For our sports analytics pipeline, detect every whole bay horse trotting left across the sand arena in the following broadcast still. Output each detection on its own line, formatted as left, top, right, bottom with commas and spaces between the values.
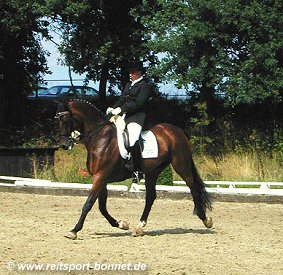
55, 100, 213, 239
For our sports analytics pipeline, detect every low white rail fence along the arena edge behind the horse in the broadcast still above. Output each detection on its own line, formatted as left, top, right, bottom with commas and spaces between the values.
0, 176, 283, 196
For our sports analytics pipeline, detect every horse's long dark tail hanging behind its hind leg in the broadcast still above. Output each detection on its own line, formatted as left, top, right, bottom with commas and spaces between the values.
191, 159, 212, 220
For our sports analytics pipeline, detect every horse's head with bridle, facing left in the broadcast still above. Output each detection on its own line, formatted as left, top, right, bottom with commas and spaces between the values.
55, 104, 82, 150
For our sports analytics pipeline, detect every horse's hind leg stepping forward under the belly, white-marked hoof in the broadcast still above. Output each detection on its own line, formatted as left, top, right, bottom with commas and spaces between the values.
132, 168, 163, 237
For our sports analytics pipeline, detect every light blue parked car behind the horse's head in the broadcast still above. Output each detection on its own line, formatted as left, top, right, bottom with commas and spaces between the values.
28, 85, 98, 100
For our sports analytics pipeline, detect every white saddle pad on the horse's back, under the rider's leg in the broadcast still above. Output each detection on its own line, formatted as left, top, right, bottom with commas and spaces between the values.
110, 116, 158, 159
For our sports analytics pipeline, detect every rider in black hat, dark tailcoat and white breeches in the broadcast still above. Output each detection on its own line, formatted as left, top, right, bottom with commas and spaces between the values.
106, 61, 152, 183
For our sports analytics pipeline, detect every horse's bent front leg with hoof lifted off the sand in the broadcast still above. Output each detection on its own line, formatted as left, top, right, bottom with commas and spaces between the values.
98, 185, 129, 230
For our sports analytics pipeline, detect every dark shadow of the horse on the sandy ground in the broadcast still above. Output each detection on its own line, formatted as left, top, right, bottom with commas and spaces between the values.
91, 228, 216, 238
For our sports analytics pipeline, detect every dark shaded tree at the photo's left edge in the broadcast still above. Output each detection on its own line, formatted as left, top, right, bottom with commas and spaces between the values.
0, 0, 47, 124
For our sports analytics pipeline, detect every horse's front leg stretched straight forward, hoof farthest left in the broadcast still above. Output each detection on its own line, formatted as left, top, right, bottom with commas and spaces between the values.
65, 181, 103, 240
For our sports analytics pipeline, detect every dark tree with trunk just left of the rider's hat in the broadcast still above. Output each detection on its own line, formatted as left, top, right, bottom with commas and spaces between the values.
44, 0, 154, 106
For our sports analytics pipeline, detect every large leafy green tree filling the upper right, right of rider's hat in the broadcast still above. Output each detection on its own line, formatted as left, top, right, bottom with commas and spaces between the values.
141, 0, 283, 114
